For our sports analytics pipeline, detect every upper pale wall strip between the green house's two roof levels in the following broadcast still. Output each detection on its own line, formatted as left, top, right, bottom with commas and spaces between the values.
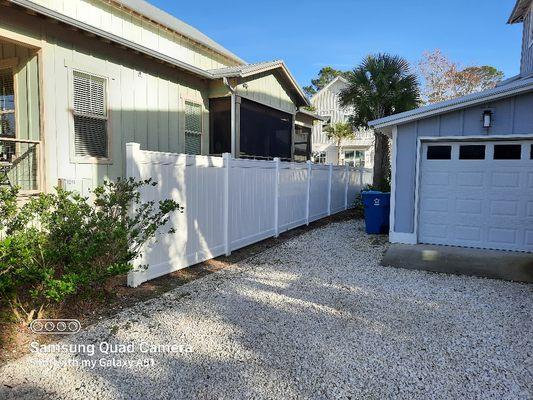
29, 0, 238, 69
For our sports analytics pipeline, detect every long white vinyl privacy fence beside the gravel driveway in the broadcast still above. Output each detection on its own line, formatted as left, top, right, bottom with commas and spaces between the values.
126, 143, 372, 287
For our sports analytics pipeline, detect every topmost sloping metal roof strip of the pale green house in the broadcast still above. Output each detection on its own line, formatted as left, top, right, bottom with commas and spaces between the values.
115, 0, 246, 64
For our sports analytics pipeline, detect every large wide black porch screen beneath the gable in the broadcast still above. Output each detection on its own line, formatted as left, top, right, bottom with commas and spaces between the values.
240, 99, 292, 158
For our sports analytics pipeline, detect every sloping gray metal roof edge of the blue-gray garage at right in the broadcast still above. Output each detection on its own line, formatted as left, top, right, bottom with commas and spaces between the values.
368, 76, 533, 129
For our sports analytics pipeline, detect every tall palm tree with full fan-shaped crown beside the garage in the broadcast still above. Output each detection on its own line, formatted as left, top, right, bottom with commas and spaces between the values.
340, 54, 420, 190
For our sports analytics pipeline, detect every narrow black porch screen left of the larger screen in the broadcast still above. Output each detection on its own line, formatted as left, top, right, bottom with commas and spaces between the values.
209, 97, 231, 154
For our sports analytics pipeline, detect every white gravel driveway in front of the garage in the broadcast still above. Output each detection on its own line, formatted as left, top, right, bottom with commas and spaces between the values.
0, 221, 533, 399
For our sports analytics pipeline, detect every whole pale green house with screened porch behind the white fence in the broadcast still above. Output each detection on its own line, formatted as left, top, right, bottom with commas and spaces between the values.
0, 0, 312, 193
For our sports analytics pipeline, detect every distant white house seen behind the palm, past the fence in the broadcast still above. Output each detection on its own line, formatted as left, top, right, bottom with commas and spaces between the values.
311, 76, 374, 168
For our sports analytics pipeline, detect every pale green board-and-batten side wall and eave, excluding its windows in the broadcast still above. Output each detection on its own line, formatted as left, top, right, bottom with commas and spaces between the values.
0, 7, 209, 190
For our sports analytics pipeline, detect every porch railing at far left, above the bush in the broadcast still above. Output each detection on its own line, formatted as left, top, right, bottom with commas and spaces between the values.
0, 137, 41, 193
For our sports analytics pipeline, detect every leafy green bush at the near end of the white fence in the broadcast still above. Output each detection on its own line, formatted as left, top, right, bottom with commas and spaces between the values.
0, 179, 183, 319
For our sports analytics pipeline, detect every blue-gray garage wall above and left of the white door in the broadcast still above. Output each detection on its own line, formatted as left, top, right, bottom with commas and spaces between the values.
393, 92, 533, 234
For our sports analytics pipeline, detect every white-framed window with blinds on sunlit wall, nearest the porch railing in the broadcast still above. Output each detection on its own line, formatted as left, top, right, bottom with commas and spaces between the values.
73, 71, 108, 158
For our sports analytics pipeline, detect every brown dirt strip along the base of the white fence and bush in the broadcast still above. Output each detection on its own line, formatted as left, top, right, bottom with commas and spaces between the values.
0, 210, 356, 365
